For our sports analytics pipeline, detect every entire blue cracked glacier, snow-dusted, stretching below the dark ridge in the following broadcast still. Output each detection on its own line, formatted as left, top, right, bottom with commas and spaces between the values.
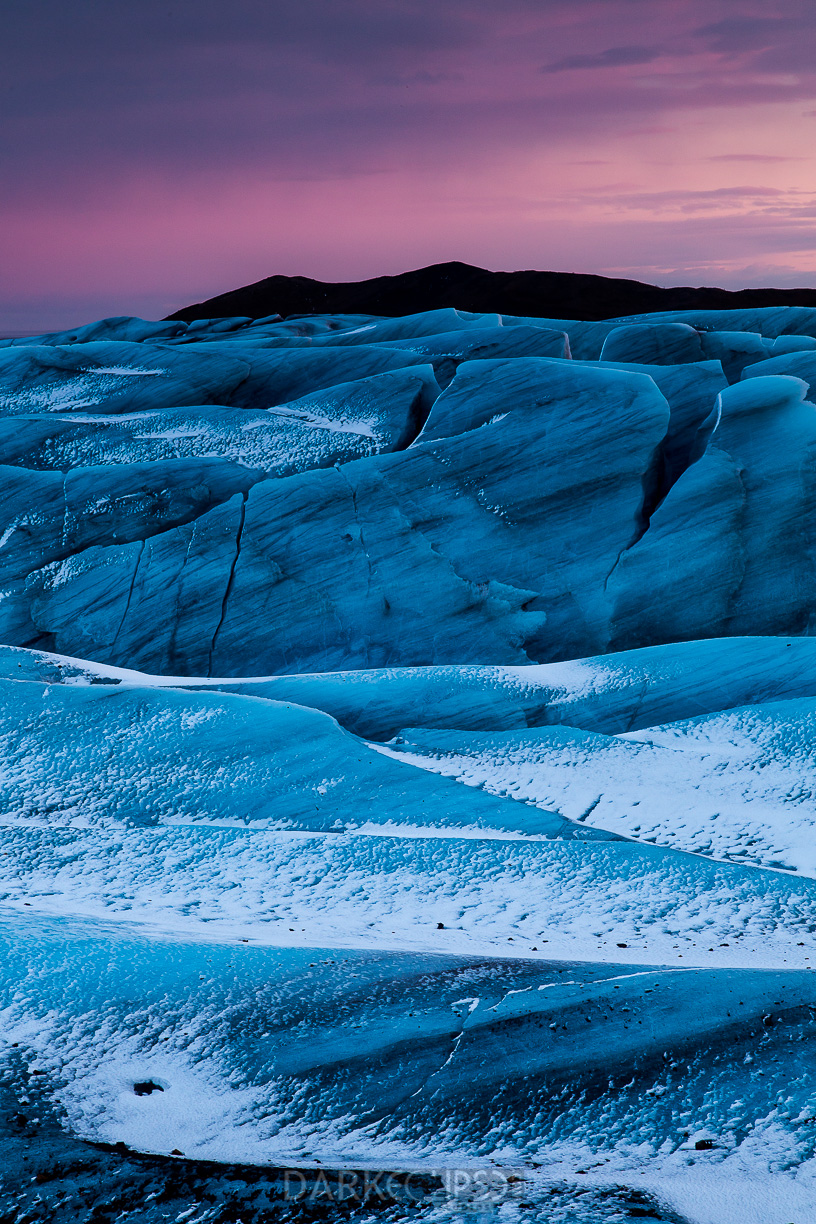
0, 307, 816, 1224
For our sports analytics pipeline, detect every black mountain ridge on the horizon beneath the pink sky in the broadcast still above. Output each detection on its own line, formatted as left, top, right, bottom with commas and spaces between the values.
168, 261, 816, 322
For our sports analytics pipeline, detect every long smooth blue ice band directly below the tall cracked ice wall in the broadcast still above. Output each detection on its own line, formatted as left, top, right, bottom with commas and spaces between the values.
0, 638, 816, 741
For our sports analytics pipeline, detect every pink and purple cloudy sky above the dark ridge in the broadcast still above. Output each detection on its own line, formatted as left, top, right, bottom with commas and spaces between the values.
0, 0, 816, 330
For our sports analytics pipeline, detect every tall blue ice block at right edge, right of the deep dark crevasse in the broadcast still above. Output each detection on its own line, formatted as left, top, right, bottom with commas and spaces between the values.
609, 372, 816, 647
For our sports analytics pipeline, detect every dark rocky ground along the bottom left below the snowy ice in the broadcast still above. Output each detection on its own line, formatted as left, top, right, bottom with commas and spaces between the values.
0, 1082, 684, 1224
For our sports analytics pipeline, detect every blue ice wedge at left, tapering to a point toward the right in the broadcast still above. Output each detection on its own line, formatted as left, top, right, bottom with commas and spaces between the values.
0, 681, 611, 837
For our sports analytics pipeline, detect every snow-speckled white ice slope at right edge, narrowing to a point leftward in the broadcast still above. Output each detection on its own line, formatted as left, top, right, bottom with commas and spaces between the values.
381, 699, 816, 875
